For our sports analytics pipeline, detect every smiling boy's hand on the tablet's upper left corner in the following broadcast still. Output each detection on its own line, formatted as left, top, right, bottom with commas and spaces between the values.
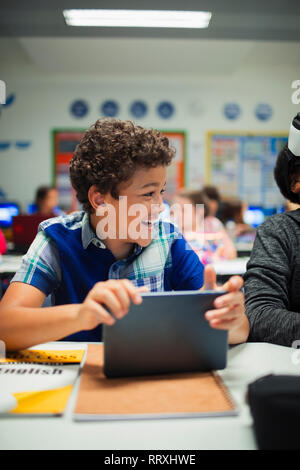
77, 279, 149, 330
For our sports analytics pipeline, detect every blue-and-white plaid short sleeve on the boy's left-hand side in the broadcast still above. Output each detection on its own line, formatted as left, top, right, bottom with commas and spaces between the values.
11, 231, 61, 296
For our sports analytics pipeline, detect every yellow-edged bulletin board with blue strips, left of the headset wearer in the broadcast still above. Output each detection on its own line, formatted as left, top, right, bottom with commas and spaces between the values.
206, 131, 288, 208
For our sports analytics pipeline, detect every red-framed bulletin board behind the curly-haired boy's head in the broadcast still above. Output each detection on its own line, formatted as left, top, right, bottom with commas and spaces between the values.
52, 129, 186, 211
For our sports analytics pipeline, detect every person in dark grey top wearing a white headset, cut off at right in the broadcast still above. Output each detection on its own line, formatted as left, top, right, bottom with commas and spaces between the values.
244, 113, 300, 346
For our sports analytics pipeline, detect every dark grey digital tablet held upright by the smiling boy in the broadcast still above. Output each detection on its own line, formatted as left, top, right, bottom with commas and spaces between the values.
103, 291, 228, 377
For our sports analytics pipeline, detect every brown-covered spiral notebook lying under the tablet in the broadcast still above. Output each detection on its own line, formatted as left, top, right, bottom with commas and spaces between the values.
74, 344, 238, 421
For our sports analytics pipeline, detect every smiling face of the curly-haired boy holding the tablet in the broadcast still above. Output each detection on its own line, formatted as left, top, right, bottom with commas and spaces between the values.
91, 165, 166, 257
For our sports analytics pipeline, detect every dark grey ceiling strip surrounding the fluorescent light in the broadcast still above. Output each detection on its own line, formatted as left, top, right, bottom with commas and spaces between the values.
0, 0, 300, 41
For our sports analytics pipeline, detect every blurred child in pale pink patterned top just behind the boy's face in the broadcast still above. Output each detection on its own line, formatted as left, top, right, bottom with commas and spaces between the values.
173, 190, 237, 265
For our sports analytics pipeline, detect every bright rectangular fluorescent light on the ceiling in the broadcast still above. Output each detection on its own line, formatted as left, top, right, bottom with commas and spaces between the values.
63, 10, 211, 28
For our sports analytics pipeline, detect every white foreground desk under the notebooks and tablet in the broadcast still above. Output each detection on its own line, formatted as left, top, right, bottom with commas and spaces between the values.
0, 343, 300, 450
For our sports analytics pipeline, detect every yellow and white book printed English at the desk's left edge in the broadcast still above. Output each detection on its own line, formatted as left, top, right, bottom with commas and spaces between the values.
0, 347, 85, 416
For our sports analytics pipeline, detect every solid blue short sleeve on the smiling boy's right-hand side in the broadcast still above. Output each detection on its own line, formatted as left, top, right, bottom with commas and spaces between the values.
165, 237, 204, 290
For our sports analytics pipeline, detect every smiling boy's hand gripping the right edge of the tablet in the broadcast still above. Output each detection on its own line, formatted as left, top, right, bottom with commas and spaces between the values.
201, 266, 245, 331
